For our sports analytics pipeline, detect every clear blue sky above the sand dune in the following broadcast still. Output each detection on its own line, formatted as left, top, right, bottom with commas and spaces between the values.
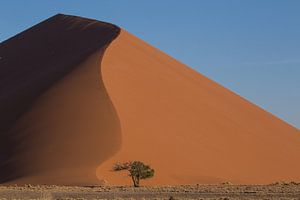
0, 0, 300, 128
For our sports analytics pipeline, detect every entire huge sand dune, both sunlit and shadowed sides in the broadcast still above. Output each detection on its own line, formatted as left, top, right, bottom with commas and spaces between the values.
0, 15, 300, 185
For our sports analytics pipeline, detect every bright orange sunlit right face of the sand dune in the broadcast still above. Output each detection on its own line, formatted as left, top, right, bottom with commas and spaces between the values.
98, 30, 300, 184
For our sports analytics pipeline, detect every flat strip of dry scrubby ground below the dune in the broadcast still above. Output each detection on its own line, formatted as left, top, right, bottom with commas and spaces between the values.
0, 183, 300, 200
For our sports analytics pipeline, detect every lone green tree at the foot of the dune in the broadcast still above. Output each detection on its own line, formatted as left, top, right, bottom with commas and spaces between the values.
113, 161, 154, 187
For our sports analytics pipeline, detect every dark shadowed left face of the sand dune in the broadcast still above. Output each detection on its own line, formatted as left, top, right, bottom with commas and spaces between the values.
0, 15, 121, 184
